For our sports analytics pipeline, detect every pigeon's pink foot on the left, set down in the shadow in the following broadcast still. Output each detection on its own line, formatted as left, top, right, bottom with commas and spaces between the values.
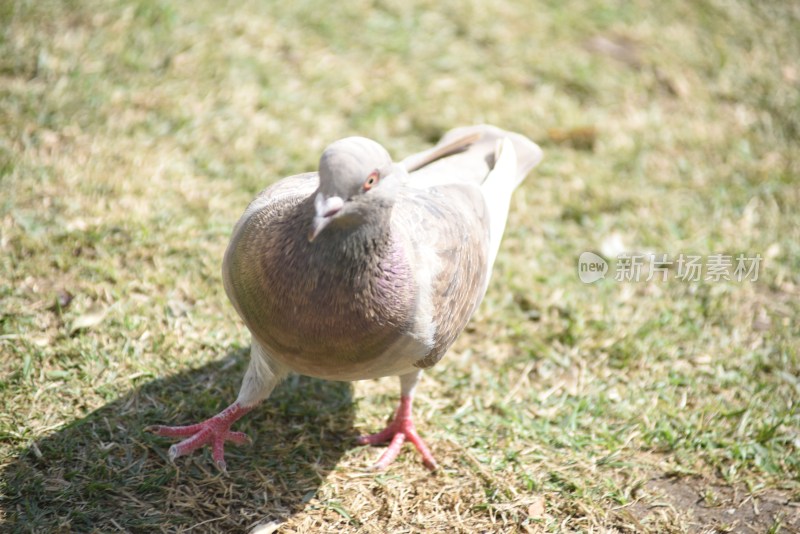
145, 402, 253, 472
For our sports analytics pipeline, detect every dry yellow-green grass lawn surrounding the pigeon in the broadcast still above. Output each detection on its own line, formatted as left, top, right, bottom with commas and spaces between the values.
0, 0, 800, 532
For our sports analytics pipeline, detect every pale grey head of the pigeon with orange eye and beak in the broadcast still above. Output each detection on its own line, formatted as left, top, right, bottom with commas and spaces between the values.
308, 137, 405, 241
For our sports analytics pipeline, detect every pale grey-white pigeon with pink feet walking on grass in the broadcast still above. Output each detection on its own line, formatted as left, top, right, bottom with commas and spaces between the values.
148, 125, 542, 472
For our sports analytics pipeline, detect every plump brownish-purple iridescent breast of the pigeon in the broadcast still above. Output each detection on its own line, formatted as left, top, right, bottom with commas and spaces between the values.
226, 180, 423, 380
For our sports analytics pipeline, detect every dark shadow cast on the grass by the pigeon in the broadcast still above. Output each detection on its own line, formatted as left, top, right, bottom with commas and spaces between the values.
0, 349, 356, 532
